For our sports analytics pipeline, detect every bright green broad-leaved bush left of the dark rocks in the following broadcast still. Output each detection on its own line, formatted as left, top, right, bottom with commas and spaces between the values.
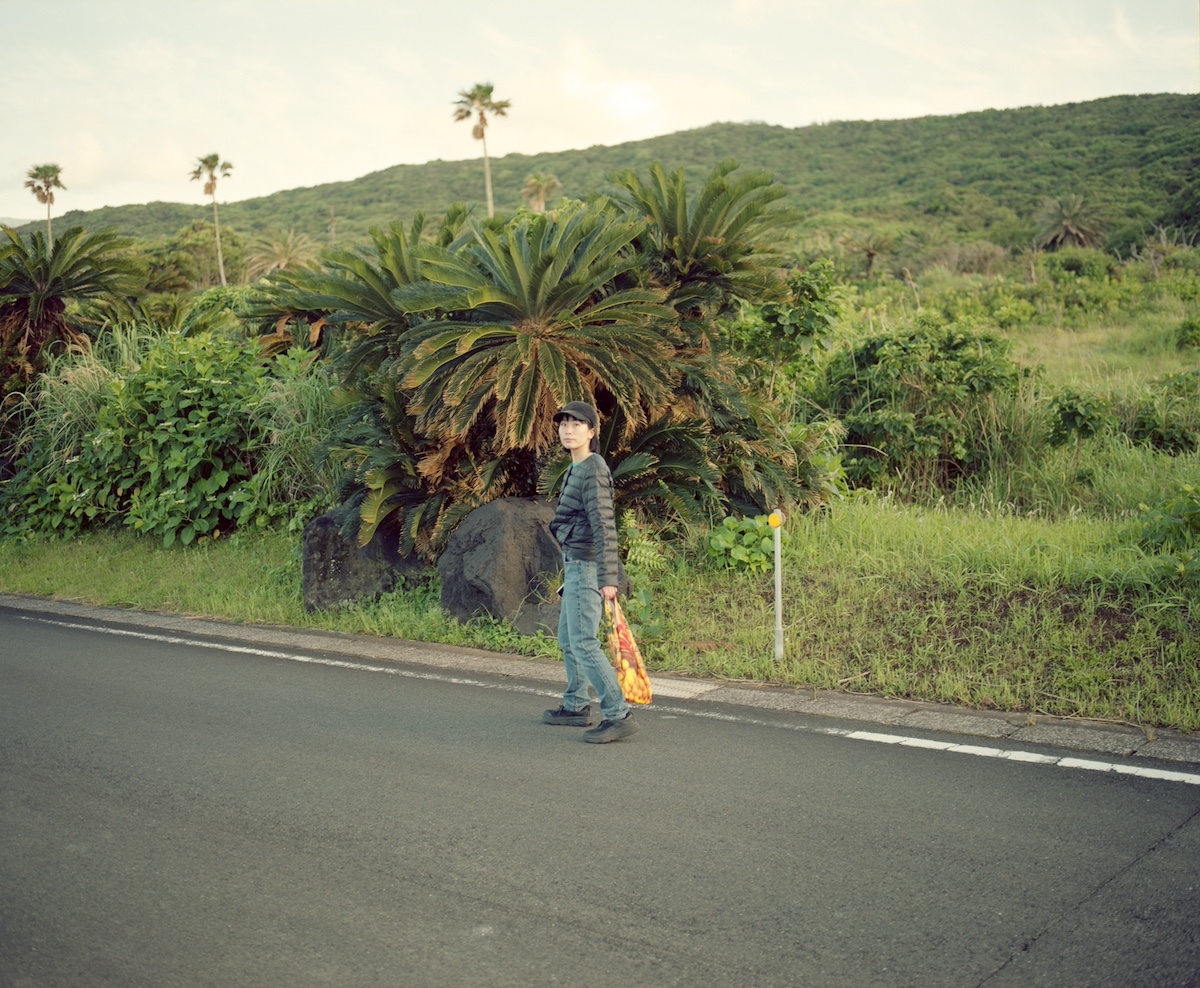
6, 335, 281, 545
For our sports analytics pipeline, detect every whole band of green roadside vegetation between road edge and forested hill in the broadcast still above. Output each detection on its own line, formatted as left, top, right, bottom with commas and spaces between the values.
0, 94, 1200, 731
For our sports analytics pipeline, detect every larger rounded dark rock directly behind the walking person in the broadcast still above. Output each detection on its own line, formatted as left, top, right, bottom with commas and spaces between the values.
438, 497, 563, 635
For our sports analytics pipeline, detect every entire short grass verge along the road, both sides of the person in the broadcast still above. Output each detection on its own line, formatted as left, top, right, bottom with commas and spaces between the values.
0, 501, 1200, 731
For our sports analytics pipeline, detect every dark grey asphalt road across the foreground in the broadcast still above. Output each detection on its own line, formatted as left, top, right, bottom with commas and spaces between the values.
0, 607, 1200, 988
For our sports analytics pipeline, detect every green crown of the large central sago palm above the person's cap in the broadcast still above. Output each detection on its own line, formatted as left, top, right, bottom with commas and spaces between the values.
392, 205, 674, 455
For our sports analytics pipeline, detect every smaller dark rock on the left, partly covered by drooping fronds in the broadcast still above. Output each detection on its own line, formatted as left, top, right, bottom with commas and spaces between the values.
304, 508, 430, 611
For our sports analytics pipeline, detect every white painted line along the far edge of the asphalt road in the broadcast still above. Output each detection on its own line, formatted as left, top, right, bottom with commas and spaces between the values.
19, 615, 1200, 785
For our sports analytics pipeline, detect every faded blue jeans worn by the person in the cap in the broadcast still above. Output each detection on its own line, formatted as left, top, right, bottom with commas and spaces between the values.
558, 559, 629, 720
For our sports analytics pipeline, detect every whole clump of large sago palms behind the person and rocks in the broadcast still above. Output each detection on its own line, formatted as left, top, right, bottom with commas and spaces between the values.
272, 162, 830, 552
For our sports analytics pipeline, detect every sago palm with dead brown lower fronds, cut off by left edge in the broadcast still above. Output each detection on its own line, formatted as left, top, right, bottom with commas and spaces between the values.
0, 227, 144, 444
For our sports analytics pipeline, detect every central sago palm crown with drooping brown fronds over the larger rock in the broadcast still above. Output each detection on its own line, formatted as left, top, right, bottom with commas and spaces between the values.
355, 205, 674, 553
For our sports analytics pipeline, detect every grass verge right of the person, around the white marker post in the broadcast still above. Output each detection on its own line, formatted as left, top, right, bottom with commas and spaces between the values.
647, 499, 1200, 730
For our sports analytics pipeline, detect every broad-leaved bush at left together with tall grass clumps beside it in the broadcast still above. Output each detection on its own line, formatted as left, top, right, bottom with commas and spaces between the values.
0, 333, 330, 545
